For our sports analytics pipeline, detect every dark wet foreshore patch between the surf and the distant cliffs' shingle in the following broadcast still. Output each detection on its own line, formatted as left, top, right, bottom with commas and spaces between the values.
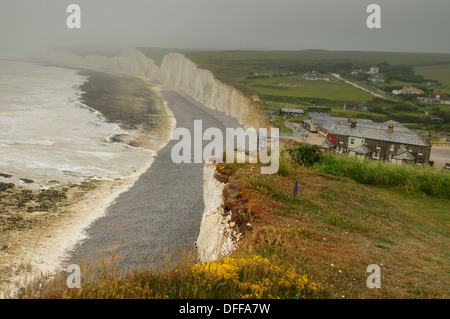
80, 70, 172, 151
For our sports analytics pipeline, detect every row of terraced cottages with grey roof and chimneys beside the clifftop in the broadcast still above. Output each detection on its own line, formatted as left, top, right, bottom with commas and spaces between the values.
308, 114, 431, 165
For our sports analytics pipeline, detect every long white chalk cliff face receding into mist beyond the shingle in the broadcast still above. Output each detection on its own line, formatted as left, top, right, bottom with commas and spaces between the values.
47, 49, 272, 129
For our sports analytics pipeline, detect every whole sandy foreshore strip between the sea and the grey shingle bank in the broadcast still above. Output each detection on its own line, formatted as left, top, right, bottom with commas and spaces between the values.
0, 70, 175, 298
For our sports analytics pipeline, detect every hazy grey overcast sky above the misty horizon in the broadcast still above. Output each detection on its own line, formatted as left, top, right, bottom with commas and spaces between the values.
0, 0, 450, 54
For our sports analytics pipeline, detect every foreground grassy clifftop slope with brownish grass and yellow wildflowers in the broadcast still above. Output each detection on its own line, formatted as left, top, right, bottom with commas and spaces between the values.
18, 154, 450, 299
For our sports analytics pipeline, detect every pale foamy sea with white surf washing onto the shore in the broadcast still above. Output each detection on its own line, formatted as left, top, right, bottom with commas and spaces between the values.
0, 60, 155, 187
